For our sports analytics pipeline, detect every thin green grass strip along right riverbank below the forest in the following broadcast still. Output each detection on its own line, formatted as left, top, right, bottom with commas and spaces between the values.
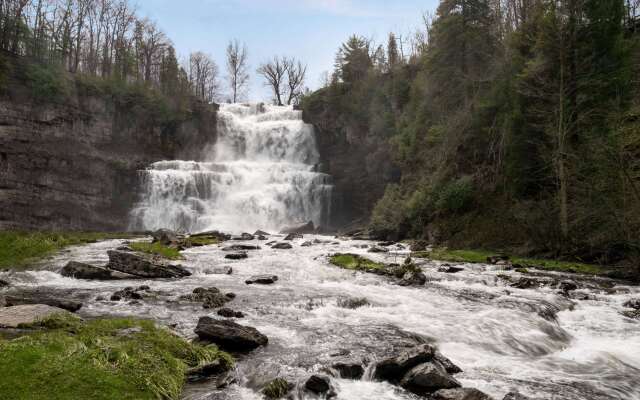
411, 248, 609, 275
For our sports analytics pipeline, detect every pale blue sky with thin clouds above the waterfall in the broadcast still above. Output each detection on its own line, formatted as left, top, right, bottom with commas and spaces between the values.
137, 0, 438, 101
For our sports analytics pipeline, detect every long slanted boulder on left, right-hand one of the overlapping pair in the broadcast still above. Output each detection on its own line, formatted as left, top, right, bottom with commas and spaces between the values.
107, 250, 191, 278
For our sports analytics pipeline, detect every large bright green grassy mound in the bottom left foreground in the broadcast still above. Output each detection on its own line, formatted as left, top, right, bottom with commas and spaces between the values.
0, 318, 233, 400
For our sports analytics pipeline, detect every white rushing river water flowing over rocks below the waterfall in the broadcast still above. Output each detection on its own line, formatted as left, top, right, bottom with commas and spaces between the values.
5, 236, 640, 400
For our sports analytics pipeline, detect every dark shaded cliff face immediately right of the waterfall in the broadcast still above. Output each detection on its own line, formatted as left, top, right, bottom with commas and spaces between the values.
303, 95, 398, 228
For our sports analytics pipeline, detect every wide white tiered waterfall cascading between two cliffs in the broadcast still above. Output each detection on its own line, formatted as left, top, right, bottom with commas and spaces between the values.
130, 104, 332, 233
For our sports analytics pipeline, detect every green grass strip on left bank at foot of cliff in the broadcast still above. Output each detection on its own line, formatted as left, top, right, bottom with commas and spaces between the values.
0, 231, 141, 270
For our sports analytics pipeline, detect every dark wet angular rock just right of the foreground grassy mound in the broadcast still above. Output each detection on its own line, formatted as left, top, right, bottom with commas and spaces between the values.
195, 317, 269, 351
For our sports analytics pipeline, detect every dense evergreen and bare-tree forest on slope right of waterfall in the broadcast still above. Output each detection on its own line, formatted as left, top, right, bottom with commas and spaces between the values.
303, 0, 640, 268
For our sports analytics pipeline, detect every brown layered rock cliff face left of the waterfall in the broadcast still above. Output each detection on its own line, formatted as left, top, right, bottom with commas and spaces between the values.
0, 91, 216, 230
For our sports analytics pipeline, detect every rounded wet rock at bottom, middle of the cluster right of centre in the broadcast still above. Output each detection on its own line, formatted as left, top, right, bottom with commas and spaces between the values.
400, 362, 461, 395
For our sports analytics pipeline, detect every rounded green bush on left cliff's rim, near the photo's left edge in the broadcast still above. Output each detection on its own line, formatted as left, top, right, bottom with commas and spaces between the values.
24, 63, 71, 102
